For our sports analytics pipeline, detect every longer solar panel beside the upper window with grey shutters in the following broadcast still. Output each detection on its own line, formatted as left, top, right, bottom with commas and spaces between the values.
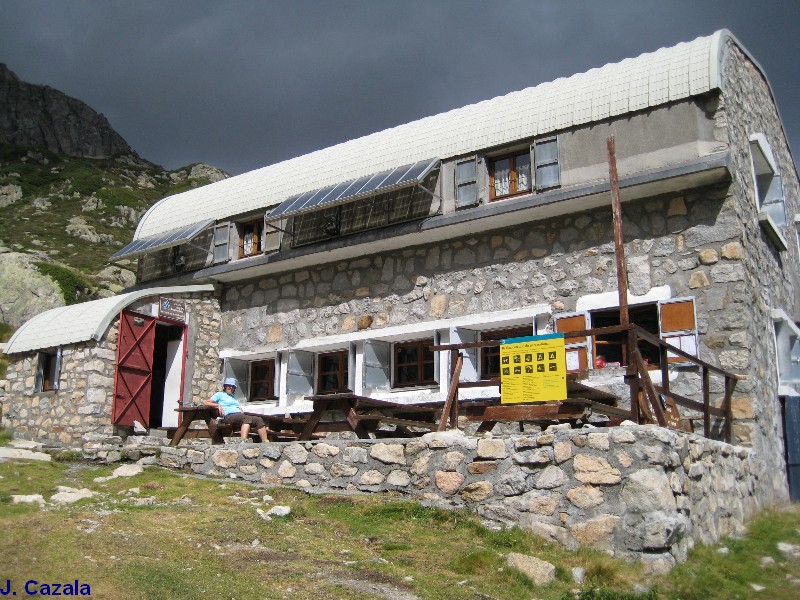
268, 158, 439, 220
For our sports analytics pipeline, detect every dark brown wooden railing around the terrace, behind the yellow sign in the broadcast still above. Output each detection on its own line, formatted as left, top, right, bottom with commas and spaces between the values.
432, 325, 744, 443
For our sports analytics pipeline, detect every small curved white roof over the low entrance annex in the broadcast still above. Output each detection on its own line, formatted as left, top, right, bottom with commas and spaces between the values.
5, 284, 214, 354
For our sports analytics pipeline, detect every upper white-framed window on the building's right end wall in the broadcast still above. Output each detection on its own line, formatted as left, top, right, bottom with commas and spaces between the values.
750, 133, 789, 252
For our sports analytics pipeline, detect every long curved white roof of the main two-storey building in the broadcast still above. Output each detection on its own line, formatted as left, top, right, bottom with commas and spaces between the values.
134, 30, 741, 240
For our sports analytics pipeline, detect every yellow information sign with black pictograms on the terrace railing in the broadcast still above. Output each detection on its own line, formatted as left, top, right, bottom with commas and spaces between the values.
500, 333, 567, 404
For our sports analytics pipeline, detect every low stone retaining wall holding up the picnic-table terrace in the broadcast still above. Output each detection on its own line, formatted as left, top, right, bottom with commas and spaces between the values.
100, 422, 768, 571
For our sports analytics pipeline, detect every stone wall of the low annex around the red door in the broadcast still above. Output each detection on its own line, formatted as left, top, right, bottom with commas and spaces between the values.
0, 294, 219, 445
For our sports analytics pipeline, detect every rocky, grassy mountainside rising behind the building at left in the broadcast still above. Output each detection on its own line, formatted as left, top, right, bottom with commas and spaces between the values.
0, 65, 228, 327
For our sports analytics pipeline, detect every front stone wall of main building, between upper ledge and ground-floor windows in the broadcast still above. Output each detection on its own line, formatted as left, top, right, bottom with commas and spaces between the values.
220, 184, 757, 426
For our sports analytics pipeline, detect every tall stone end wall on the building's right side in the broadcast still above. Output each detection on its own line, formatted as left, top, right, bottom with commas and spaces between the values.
721, 44, 800, 497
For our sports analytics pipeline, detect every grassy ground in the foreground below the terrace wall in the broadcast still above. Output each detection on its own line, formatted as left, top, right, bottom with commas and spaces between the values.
0, 462, 800, 600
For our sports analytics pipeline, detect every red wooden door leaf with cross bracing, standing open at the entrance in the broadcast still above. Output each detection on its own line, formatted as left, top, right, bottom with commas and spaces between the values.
111, 310, 156, 427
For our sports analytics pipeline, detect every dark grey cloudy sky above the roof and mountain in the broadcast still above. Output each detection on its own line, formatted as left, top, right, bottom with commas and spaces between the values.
0, 0, 800, 174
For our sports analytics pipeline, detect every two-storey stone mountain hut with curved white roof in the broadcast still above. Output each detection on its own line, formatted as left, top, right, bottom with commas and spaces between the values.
4, 31, 800, 501
